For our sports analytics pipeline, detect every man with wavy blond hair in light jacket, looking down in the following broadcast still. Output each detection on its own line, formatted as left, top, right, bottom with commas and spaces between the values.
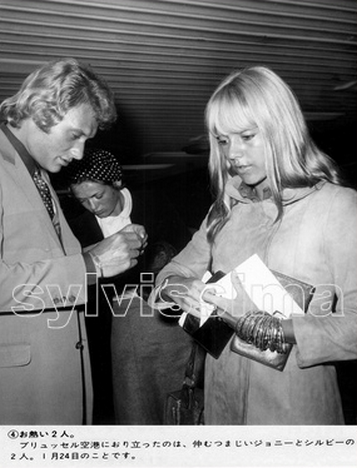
0, 59, 146, 425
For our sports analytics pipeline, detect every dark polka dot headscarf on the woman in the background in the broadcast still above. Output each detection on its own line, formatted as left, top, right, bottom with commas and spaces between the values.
66, 149, 122, 185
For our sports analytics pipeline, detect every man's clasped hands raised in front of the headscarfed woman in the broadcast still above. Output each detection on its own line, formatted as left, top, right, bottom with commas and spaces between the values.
87, 224, 147, 278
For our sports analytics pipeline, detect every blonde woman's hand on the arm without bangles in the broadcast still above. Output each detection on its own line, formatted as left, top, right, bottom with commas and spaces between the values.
159, 276, 205, 317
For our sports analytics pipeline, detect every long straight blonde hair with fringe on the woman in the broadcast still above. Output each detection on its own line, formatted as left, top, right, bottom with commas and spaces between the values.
205, 66, 342, 242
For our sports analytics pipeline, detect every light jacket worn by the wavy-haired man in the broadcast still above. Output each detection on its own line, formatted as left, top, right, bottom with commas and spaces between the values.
0, 131, 92, 425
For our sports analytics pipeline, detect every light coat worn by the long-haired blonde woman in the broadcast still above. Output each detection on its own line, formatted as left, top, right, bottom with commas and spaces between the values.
157, 178, 357, 425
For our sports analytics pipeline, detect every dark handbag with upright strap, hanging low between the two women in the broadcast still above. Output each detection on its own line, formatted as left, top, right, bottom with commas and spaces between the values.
164, 342, 206, 426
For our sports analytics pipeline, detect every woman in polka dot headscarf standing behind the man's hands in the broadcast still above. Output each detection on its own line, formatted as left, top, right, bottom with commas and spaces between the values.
65, 149, 190, 425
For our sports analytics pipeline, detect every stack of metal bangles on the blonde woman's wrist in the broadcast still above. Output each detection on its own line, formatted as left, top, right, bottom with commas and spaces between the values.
235, 310, 288, 354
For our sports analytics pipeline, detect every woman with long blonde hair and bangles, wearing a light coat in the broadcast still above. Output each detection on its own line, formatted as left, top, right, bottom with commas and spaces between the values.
152, 66, 357, 425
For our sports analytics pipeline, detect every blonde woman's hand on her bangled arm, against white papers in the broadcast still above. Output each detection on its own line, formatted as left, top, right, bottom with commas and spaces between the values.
202, 270, 257, 326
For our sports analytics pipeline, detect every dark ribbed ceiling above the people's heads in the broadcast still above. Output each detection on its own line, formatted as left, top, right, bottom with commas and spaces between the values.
0, 0, 356, 153
